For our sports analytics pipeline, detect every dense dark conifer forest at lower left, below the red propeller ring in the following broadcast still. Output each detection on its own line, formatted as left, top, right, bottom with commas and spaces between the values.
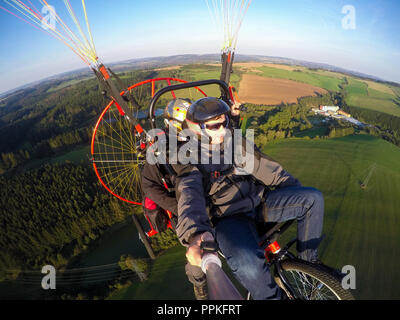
0, 163, 140, 279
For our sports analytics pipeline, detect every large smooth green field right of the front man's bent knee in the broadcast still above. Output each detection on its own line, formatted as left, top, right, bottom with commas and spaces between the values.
263, 135, 400, 299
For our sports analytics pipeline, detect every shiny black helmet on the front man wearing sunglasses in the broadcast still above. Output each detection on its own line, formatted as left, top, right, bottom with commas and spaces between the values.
186, 97, 230, 123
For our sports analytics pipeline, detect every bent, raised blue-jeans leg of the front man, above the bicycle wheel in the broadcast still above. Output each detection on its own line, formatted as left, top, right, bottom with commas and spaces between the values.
264, 187, 324, 261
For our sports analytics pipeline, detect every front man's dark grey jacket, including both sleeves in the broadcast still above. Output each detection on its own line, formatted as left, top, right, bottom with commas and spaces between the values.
173, 131, 301, 246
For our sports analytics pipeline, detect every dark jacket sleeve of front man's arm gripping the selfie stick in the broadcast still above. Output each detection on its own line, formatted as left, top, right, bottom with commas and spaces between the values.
174, 165, 213, 246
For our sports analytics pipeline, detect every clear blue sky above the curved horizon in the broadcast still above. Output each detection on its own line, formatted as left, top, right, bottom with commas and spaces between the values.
0, 0, 400, 92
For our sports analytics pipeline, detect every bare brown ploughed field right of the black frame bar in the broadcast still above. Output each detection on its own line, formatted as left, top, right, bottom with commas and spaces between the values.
239, 74, 327, 105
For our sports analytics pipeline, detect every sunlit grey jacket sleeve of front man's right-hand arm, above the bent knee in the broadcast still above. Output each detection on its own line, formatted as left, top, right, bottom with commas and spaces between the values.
243, 139, 301, 188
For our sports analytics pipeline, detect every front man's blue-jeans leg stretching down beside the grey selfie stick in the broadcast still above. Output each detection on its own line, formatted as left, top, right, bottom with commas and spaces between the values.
215, 216, 280, 300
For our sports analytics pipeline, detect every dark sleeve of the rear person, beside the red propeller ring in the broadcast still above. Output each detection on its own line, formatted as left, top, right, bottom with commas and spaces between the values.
141, 163, 178, 215
